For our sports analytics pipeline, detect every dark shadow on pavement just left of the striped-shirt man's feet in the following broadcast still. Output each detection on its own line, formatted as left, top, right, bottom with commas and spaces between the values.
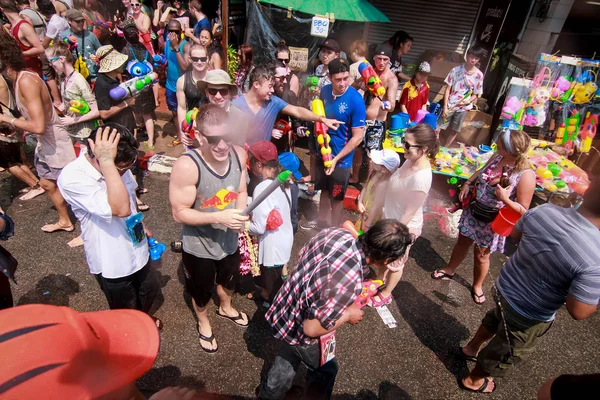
394, 281, 469, 377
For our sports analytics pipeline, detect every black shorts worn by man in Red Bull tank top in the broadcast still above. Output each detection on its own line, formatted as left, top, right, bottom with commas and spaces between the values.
183, 250, 240, 307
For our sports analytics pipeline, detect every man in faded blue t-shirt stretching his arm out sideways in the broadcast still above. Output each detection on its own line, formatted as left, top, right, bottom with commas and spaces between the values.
231, 66, 342, 145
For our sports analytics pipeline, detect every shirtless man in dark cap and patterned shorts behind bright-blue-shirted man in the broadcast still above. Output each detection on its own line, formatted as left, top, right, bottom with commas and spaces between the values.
350, 44, 398, 183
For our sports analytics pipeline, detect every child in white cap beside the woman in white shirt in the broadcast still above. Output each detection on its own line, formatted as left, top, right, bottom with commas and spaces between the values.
356, 149, 400, 231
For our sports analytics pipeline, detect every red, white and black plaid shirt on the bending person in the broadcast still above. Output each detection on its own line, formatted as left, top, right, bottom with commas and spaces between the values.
265, 229, 369, 345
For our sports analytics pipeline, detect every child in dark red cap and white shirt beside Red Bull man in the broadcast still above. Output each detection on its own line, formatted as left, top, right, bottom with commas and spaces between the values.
248, 140, 294, 302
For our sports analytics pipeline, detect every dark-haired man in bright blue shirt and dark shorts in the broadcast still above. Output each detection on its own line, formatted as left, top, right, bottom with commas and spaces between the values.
300, 58, 367, 229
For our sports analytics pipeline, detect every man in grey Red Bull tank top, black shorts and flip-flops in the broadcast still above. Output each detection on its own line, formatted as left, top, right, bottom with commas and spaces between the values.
169, 104, 248, 353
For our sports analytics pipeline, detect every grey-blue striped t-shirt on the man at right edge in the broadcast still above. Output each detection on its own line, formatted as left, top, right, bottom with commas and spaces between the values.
496, 204, 600, 322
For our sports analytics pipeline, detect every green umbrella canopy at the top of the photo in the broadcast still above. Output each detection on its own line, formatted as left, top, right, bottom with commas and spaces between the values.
259, 0, 390, 22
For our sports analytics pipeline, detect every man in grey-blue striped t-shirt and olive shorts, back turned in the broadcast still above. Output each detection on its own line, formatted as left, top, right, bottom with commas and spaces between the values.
459, 178, 600, 393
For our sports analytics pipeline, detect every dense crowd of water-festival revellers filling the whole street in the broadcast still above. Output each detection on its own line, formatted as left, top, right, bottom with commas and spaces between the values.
0, 0, 600, 400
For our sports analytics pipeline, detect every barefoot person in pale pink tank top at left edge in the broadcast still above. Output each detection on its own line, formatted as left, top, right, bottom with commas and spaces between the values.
0, 31, 75, 232
